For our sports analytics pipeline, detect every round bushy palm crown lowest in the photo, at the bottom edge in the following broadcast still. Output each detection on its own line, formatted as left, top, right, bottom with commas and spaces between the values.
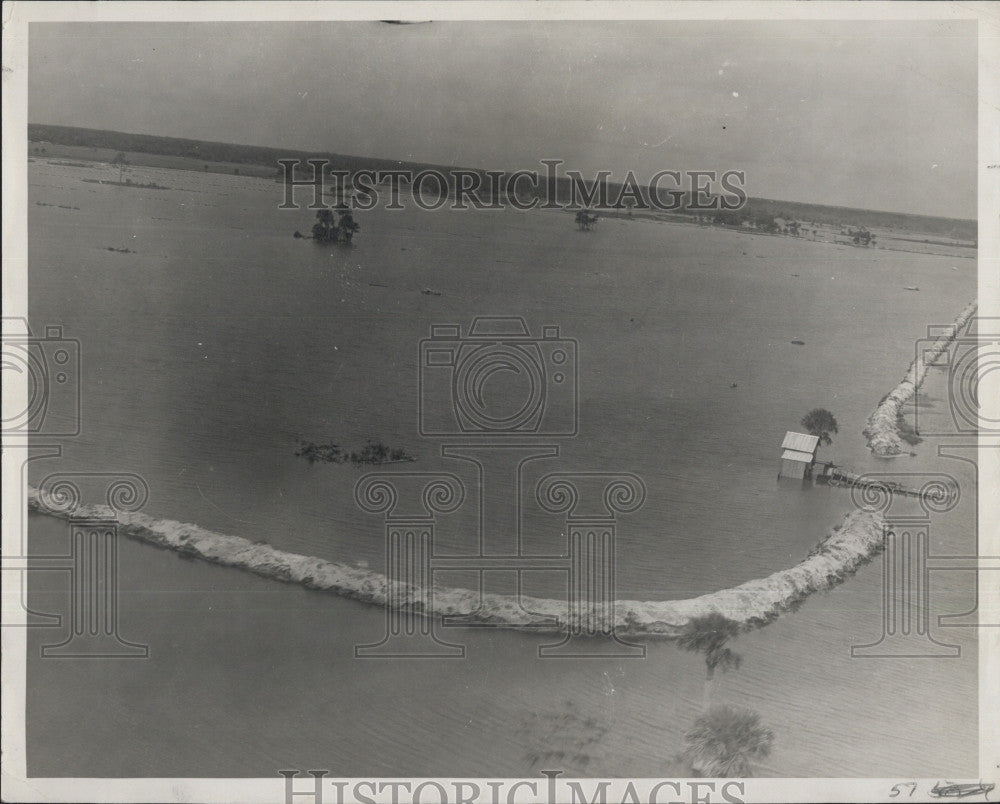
684, 704, 774, 778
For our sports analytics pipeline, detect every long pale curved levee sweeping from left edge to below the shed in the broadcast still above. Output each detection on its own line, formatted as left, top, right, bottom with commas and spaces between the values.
28, 489, 884, 638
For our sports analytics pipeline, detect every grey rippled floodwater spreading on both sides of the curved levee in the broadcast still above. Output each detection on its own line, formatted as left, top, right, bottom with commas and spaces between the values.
27, 162, 978, 777
